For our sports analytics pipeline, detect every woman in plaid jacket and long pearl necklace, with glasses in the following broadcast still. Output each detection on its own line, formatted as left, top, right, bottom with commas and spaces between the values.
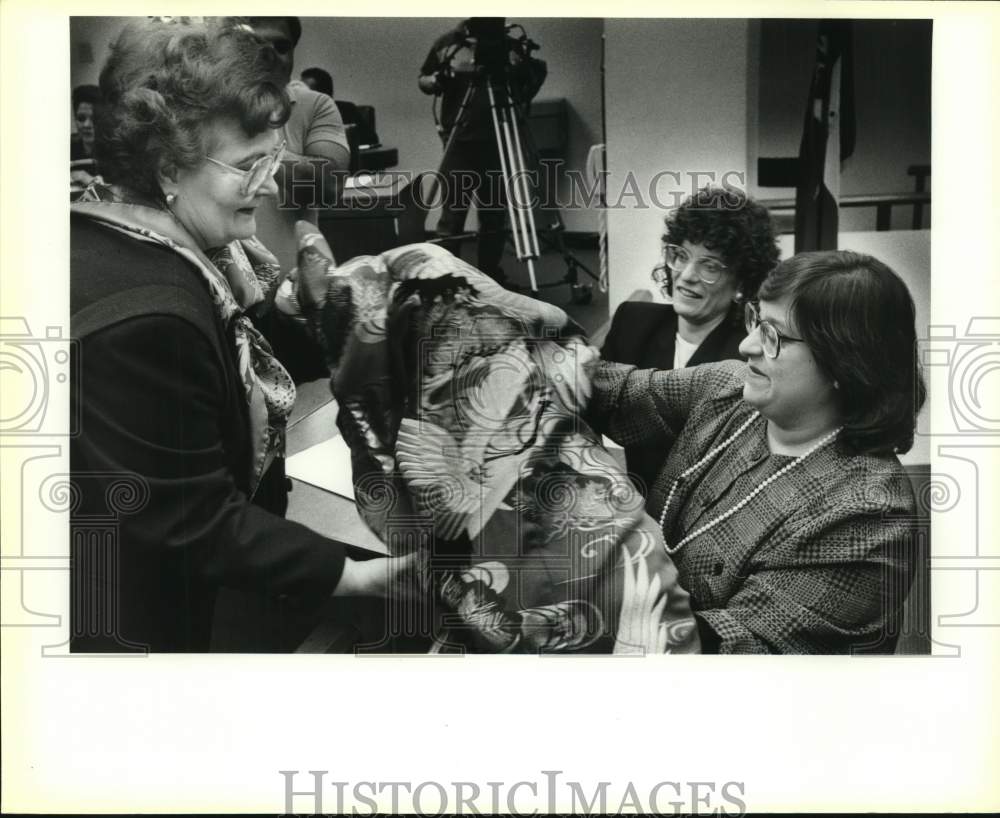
591, 252, 925, 653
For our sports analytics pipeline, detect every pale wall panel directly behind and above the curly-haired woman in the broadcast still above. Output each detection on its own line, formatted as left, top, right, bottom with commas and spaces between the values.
605, 20, 749, 313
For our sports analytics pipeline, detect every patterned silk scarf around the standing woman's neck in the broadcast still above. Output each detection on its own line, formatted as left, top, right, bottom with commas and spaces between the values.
71, 184, 295, 496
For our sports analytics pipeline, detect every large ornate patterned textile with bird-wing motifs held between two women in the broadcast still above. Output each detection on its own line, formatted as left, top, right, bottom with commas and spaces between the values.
297, 233, 699, 653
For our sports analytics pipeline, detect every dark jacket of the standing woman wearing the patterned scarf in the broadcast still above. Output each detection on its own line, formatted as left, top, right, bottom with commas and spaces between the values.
70, 215, 344, 651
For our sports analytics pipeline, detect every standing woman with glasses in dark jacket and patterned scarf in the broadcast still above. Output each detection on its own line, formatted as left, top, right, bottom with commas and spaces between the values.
71, 20, 412, 651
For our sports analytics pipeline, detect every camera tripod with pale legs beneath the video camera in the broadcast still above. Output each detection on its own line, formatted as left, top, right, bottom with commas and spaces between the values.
431, 65, 599, 303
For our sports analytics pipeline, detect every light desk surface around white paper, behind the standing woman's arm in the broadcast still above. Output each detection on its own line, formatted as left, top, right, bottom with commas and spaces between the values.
285, 378, 388, 554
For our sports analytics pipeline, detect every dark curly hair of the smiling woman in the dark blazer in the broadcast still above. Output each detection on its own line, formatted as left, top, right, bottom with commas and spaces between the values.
654, 185, 779, 300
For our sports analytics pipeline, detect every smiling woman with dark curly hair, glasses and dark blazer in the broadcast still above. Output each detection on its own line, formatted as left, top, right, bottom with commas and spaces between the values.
601, 186, 778, 493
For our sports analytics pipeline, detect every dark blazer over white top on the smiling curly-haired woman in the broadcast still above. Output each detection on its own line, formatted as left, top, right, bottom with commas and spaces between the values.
601, 301, 746, 496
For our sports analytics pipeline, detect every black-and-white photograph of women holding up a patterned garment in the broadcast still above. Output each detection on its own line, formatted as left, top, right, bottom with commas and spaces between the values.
64, 12, 933, 654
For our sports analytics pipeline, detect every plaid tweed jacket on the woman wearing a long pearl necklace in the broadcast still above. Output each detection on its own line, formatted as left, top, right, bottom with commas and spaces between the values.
590, 361, 916, 653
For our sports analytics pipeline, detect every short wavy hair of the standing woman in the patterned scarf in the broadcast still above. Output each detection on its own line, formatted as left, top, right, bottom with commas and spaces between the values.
95, 20, 291, 202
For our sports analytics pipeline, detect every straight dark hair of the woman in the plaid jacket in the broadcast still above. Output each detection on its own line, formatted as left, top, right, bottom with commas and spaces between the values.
758, 250, 927, 454
